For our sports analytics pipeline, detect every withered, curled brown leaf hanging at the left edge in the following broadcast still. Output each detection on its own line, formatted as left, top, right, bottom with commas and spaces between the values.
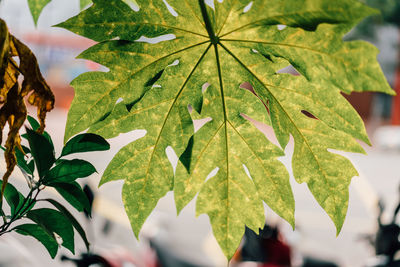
0, 19, 54, 199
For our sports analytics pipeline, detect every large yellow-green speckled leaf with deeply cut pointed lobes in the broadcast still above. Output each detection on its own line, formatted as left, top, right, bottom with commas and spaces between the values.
58, 0, 393, 258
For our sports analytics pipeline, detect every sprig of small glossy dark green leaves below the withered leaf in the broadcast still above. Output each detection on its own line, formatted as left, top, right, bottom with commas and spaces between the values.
0, 117, 109, 258
